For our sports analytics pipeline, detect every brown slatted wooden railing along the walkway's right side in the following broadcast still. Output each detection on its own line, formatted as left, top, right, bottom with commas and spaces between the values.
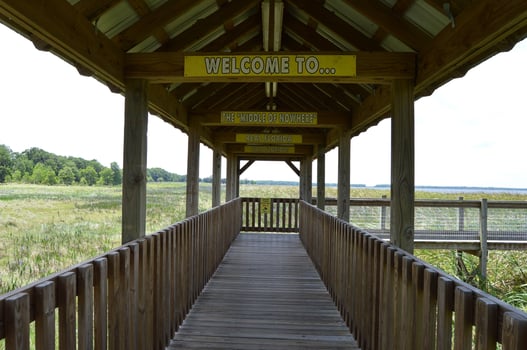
300, 201, 527, 350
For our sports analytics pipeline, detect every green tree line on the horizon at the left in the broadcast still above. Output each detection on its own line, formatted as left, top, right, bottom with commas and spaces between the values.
0, 145, 186, 186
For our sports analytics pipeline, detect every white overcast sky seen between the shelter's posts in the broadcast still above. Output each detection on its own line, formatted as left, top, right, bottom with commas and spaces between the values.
0, 24, 527, 188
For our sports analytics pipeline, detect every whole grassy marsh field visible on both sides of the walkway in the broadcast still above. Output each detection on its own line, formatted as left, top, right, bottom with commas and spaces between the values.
0, 183, 527, 310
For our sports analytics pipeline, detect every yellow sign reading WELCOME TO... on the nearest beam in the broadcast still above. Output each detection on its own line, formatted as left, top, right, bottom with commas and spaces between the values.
184, 54, 357, 77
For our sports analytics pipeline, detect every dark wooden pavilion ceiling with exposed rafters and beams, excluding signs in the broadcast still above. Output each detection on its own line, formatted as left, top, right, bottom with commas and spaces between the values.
0, 0, 527, 160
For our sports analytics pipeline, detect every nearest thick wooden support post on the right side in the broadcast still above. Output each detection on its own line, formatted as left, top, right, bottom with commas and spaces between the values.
390, 80, 415, 253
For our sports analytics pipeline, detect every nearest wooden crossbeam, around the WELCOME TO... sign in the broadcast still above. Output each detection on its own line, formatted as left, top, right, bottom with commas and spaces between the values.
125, 52, 416, 84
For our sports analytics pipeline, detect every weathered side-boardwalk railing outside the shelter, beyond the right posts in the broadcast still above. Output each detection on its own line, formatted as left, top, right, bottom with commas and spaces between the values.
314, 197, 527, 251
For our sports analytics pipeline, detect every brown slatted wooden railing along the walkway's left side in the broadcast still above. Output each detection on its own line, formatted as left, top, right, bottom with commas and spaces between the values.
0, 199, 241, 350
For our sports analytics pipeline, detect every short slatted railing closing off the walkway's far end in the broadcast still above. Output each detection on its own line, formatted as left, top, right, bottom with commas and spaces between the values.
242, 198, 299, 232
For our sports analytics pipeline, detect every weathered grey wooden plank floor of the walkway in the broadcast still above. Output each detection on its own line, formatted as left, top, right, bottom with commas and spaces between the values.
168, 234, 358, 350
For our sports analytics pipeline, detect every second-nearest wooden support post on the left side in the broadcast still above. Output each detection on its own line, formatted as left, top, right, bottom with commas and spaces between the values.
186, 118, 200, 218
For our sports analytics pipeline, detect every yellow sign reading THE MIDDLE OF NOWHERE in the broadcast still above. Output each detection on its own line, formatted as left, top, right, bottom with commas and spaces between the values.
221, 111, 318, 126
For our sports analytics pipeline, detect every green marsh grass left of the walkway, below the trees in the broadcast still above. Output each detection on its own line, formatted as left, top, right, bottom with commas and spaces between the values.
0, 183, 211, 294
